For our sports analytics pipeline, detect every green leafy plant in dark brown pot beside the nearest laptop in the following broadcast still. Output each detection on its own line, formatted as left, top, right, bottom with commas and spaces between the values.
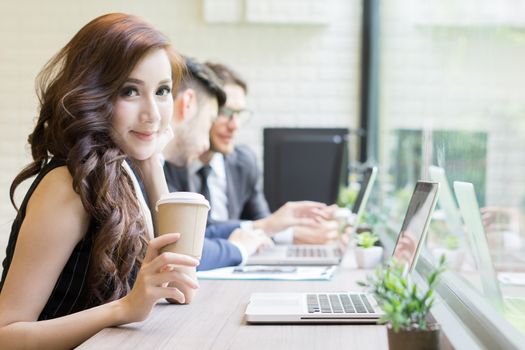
359, 256, 445, 350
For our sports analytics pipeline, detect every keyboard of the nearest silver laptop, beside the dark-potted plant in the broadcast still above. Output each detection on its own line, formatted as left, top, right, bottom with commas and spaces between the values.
306, 293, 374, 314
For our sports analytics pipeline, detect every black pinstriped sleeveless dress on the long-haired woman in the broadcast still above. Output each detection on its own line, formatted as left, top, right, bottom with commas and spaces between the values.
0, 159, 137, 320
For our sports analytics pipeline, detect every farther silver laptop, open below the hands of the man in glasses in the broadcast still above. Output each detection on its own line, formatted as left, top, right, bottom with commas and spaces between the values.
246, 167, 377, 265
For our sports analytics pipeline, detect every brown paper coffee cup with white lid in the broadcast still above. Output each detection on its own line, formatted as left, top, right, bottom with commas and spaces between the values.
156, 192, 210, 259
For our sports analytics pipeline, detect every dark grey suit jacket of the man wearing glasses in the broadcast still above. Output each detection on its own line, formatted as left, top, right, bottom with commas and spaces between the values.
164, 146, 271, 223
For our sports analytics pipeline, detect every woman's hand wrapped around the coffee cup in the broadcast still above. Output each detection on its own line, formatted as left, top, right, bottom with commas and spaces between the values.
116, 233, 199, 323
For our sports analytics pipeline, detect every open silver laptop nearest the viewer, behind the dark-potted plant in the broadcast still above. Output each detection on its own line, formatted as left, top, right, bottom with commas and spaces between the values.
245, 181, 439, 324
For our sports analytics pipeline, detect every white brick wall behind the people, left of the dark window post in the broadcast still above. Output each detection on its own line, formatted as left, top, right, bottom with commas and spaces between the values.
0, 0, 361, 259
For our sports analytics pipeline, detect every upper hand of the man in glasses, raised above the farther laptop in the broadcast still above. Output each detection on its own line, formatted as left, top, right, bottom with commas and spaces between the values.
253, 201, 332, 236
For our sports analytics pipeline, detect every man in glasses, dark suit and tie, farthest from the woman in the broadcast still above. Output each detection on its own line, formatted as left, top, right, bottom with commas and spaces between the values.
166, 63, 337, 244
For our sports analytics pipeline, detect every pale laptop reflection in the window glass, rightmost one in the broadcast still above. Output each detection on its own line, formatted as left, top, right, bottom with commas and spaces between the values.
454, 181, 525, 316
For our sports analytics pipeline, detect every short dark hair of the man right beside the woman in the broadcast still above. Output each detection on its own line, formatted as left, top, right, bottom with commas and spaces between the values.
178, 57, 226, 107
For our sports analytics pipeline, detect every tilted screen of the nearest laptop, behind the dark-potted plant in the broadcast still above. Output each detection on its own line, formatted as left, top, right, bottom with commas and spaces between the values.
393, 181, 439, 271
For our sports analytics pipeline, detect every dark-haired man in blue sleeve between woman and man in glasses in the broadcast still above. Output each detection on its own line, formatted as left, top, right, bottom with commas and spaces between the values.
163, 58, 272, 270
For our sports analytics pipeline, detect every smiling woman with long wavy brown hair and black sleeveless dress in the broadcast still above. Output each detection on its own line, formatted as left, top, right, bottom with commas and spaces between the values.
0, 14, 198, 349
